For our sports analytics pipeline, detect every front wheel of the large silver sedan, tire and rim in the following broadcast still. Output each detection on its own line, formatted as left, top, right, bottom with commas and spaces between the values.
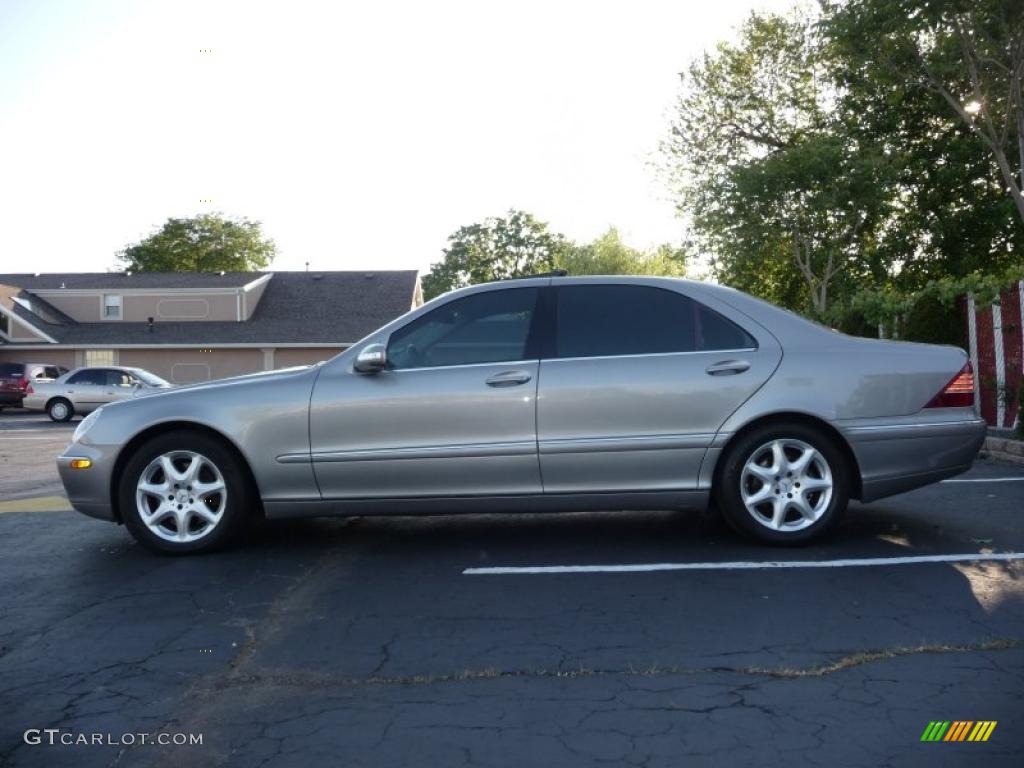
118, 430, 256, 555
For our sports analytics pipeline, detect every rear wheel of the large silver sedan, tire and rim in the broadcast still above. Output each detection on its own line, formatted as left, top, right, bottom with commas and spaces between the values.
715, 424, 853, 546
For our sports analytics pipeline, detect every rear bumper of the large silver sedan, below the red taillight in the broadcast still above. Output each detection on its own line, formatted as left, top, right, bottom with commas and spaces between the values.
840, 409, 987, 502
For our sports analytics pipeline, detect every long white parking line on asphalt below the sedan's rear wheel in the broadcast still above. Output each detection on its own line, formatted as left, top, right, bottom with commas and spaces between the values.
462, 552, 1024, 575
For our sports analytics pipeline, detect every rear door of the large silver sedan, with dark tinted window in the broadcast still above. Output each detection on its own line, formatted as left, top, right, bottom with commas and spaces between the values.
538, 281, 781, 493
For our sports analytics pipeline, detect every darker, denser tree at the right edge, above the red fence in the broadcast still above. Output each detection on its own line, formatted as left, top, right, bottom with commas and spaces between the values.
820, 0, 1024, 301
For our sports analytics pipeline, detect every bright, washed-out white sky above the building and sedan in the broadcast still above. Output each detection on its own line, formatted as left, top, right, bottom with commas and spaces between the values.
0, 0, 791, 271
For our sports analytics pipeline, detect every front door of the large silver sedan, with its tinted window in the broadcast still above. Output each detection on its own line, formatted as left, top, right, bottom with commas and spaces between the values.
309, 287, 541, 499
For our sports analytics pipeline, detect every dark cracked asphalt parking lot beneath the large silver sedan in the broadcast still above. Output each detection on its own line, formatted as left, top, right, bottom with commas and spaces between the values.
0, 413, 1024, 768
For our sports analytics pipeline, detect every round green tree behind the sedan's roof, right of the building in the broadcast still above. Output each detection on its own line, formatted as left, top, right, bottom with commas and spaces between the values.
423, 210, 569, 299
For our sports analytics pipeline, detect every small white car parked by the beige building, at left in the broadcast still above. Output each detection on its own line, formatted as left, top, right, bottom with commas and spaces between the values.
22, 366, 174, 421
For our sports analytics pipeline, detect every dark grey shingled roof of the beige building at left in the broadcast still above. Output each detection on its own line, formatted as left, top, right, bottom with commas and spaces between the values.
0, 269, 418, 347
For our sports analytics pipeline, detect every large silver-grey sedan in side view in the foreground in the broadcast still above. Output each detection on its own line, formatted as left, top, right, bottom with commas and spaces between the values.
57, 276, 985, 553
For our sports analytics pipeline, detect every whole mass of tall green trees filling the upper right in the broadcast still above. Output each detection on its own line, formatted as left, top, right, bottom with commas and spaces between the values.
663, 0, 1024, 335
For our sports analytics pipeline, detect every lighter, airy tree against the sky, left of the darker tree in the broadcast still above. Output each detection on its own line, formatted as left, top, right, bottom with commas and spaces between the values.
663, 11, 887, 316
